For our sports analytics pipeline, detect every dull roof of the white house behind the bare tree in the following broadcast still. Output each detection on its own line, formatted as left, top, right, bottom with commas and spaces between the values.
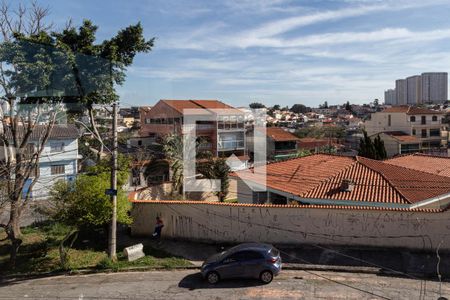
5, 124, 80, 141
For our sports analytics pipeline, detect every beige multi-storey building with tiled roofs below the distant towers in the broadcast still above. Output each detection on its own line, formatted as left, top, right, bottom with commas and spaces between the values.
364, 106, 447, 157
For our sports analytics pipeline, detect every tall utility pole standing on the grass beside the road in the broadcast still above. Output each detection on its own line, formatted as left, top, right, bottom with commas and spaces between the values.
108, 103, 117, 260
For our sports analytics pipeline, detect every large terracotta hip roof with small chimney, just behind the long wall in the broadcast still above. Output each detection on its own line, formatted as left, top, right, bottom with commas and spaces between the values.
232, 154, 450, 204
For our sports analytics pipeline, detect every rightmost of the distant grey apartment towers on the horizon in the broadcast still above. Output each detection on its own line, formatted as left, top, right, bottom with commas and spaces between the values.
422, 72, 448, 103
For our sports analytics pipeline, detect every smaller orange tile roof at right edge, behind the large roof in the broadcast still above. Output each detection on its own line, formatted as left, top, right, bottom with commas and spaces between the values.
384, 153, 450, 177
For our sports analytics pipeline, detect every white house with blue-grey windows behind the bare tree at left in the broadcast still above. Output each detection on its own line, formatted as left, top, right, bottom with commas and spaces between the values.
0, 124, 80, 199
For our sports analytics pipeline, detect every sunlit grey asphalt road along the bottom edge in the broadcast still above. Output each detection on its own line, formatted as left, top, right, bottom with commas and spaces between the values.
0, 270, 450, 300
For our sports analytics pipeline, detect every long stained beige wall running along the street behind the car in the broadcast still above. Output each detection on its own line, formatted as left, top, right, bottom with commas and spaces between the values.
132, 201, 450, 251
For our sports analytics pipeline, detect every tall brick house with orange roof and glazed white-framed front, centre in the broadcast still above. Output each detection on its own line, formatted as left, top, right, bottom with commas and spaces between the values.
139, 100, 248, 169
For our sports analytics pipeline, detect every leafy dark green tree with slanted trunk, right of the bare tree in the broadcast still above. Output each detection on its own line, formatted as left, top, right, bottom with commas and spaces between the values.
52, 20, 154, 159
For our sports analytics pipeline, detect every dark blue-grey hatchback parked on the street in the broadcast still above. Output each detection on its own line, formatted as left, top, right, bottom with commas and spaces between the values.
201, 243, 281, 284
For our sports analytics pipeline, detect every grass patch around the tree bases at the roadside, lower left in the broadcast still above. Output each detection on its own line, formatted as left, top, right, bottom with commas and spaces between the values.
0, 223, 191, 275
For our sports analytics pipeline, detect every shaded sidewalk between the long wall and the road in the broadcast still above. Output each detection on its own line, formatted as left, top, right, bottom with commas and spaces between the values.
143, 240, 450, 280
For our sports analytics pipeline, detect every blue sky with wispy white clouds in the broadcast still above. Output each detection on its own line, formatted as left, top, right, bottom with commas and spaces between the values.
38, 0, 450, 106
